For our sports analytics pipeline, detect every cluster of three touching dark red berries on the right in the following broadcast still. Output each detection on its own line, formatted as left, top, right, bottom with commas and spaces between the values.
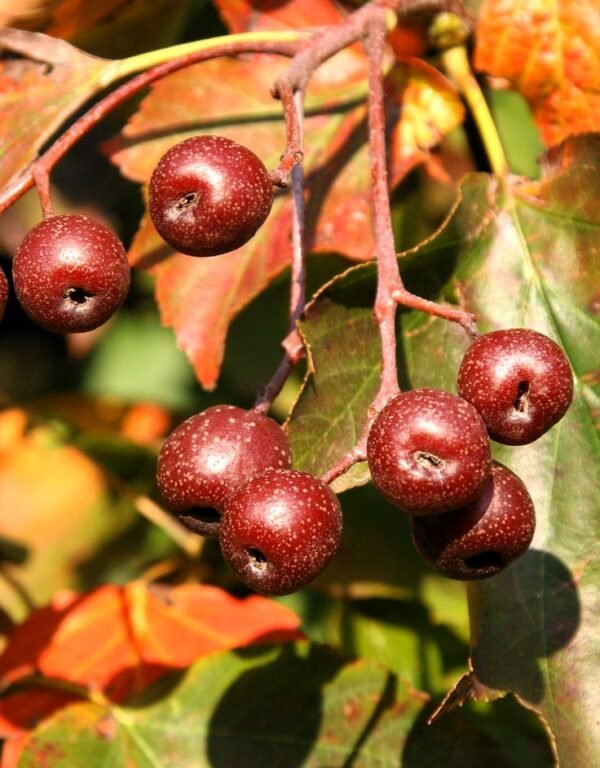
367, 328, 573, 579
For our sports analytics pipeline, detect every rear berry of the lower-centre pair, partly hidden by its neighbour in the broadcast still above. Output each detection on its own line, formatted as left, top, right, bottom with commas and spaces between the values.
156, 405, 291, 536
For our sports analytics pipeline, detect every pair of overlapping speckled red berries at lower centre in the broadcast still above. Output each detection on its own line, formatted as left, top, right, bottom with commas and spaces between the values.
157, 405, 342, 595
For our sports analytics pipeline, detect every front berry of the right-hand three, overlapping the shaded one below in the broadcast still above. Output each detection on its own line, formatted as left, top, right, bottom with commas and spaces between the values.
367, 388, 492, 515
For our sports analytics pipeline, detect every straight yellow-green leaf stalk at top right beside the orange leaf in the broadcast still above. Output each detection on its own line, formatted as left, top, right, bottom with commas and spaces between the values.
441, 45, 509, 176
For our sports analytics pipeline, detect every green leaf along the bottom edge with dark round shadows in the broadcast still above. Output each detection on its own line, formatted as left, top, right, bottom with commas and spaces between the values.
18, 643, 548, 768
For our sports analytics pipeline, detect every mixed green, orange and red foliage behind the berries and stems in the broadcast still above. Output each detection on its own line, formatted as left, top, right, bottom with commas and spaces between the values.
0, 0, 600, 768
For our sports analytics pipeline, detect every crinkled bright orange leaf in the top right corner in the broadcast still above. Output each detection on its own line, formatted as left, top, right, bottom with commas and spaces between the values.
475, 0, 600, 145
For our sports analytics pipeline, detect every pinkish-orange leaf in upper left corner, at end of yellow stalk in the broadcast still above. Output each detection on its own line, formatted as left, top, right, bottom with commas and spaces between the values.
0, 28, 110, 187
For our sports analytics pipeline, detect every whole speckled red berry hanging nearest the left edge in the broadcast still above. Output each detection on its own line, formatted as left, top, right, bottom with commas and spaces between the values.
13, 214, 130, 333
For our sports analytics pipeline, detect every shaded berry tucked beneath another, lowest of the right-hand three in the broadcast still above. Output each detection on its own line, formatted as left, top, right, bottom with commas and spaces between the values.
411, 463, 535, 580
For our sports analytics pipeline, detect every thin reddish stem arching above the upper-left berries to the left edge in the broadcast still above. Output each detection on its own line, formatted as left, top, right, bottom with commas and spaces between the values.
0, 39, 298, 218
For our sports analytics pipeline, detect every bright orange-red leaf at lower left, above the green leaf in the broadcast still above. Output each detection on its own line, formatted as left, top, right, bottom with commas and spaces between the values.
0, 582, 301, 737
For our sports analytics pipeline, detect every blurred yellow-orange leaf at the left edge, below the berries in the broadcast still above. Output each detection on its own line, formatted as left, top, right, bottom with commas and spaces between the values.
0, 410, 134, 620
